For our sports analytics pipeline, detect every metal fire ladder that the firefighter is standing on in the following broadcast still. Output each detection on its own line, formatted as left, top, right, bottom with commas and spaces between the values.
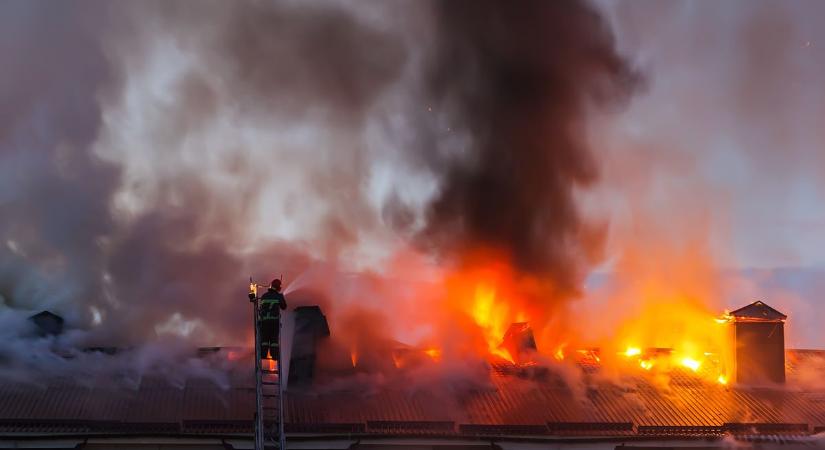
249, 278, 286, 450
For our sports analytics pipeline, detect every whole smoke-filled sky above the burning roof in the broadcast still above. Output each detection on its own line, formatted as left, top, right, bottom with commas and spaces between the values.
0, 0, 825, 347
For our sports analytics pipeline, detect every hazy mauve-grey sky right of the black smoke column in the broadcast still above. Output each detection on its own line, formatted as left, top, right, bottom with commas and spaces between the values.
600, 1, 825, 268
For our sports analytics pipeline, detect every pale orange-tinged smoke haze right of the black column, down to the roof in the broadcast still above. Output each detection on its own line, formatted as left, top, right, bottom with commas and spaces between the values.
582, 1, 825, 347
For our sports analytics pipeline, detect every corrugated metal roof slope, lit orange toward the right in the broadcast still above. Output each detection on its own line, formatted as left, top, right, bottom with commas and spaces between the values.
0, 351, 825, 436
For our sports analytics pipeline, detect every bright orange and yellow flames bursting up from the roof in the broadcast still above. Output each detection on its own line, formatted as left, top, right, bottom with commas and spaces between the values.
378, 243, 733, 385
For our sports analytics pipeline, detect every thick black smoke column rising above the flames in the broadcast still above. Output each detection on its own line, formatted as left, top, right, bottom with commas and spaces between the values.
423, 0, 637, 294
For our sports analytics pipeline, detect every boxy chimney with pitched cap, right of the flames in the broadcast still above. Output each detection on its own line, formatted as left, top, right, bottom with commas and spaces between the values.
730, 301, 788, 385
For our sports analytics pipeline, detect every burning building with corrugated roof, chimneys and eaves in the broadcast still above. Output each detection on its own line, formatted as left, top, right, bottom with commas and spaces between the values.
0, 302, 825, 449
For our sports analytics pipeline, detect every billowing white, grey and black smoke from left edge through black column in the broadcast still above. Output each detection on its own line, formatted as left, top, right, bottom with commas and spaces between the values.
0, 1, 637, 386
